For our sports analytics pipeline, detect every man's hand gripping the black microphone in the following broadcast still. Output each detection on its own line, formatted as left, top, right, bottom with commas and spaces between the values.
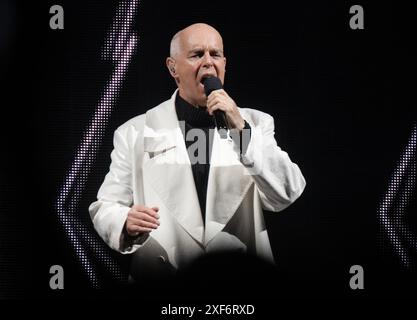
207, 89, 245, 131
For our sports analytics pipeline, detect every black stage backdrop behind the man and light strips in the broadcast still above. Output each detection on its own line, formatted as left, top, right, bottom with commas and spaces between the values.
0, 0, 417, 303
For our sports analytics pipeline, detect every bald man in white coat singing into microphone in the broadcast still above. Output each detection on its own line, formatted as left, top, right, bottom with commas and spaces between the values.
89, 23, 305, 278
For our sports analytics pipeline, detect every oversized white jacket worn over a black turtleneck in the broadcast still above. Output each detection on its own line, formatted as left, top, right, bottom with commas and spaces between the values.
89, 92, 305, 268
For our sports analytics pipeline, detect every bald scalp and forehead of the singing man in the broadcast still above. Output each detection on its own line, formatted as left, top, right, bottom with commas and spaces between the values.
169, 23, 223, 58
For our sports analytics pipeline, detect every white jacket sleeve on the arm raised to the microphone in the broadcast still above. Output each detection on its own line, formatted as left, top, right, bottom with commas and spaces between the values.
237, 113, 306, 212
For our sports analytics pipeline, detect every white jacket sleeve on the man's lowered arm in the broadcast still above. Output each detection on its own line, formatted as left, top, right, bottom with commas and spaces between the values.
89, 128, 148, 253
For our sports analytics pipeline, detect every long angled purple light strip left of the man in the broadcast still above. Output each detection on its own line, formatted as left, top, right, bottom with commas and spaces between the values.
56, 0, 138, 288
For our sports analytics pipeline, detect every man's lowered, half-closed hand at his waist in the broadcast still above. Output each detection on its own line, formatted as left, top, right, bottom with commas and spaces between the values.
126, 205, 159, 237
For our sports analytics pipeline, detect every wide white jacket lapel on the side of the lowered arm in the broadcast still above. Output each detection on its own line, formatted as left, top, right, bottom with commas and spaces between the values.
143, 92, 204, 244
